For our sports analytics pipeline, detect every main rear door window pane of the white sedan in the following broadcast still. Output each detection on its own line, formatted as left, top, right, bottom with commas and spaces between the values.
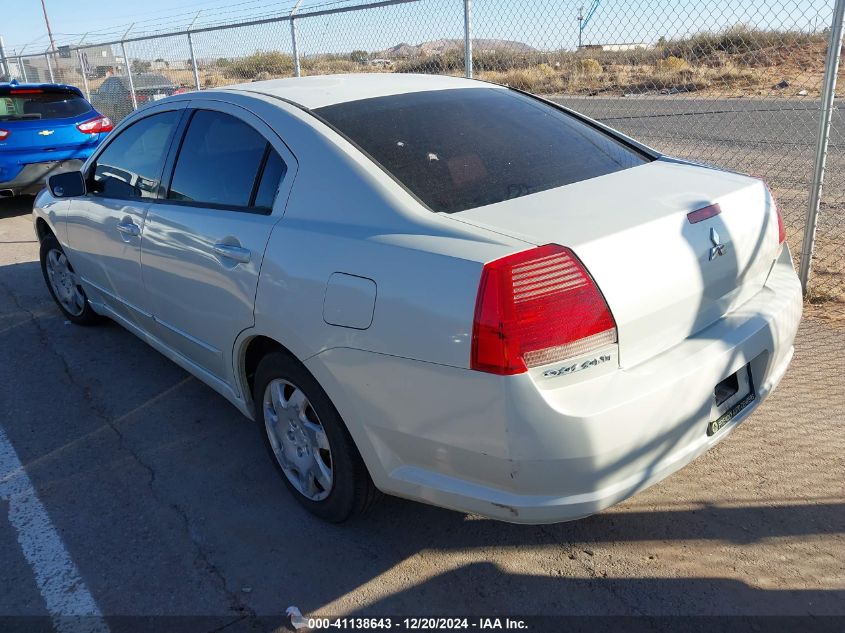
167, 110, 267, 207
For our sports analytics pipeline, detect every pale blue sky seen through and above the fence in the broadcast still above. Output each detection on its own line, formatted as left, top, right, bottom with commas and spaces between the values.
0, 0, 833, 59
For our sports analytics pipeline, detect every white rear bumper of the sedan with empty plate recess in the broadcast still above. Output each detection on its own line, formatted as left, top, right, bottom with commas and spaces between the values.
306, 249, 802, 523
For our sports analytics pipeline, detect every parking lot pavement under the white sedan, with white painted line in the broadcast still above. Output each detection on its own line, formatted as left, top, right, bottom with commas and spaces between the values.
0, 195, 845, 631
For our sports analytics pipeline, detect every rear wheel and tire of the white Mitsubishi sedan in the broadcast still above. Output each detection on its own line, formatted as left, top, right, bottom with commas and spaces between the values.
253, 352, 380, 523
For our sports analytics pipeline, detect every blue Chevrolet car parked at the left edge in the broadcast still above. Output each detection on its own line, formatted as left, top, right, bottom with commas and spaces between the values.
0, 81, 113, 196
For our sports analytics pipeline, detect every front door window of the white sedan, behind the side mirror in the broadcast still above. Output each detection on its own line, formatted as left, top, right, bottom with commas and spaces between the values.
89, 110, 181, 198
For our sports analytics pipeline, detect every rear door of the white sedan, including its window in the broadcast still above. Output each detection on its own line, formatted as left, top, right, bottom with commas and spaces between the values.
141, 101, 295, 384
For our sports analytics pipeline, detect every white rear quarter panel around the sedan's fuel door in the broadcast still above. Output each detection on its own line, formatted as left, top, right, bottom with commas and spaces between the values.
235, 90, 528, 367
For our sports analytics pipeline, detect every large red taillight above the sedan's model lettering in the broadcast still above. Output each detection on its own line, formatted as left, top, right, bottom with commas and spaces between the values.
470, 244, 616, 375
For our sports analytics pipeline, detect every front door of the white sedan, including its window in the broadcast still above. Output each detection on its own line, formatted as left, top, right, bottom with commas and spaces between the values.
66, 104, 184, 330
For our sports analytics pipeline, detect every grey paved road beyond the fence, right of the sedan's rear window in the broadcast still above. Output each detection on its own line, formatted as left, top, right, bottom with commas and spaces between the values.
555, 96, 845, 215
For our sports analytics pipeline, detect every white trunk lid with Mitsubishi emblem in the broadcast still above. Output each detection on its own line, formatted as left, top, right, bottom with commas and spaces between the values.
451, 160, 780, 367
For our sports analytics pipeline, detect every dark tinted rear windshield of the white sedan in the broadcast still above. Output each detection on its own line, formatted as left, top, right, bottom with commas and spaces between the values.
315, 88, 650, 213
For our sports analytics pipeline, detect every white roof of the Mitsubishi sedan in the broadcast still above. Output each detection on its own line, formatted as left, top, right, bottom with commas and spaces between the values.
221, 73, 505, 109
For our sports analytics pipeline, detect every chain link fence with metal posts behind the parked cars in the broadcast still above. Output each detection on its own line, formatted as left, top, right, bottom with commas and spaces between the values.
1, 0, 845, 309
